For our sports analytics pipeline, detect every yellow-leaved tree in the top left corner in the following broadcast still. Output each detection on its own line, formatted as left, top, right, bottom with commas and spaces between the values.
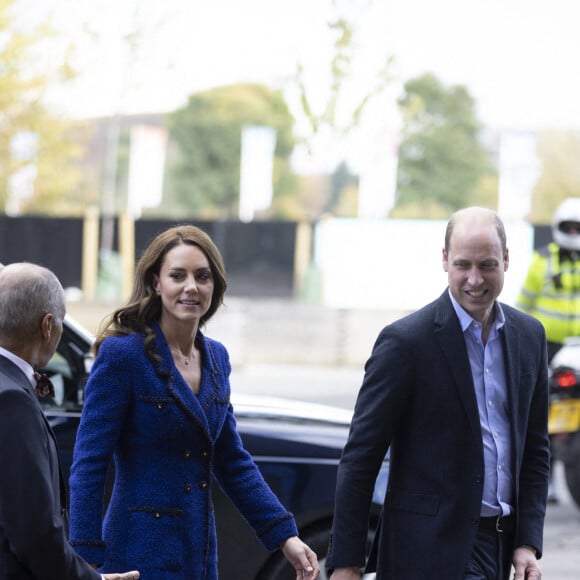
0, 0, 83, 215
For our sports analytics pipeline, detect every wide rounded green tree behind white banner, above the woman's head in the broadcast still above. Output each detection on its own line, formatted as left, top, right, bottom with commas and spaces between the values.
164, 84, 294, 218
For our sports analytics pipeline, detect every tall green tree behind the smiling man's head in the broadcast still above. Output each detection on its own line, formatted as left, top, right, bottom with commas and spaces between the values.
392, 74, 491, 218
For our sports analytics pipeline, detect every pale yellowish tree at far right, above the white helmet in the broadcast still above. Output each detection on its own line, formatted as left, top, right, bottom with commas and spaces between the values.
528, 131, 580, 224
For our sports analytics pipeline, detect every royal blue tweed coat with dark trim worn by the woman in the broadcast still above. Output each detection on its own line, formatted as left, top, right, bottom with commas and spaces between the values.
70, 327, 297, 580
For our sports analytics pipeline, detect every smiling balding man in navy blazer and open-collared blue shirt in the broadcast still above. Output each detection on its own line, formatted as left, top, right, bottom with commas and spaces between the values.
327, 208, 549, 580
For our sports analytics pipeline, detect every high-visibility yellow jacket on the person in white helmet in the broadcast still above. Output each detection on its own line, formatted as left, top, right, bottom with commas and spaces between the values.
516, 242, 580, 343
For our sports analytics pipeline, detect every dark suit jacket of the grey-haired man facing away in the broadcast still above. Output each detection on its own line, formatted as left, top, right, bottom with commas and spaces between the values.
0, 356, 101, 580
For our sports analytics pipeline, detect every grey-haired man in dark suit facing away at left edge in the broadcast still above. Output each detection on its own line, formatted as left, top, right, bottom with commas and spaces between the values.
0, 263, 139, 580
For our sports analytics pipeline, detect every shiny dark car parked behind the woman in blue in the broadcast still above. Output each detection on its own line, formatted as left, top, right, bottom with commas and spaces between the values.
42, 317, 388, 580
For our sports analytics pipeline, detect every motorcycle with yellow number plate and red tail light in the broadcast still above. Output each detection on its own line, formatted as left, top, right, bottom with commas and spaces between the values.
548, 337, 580, 508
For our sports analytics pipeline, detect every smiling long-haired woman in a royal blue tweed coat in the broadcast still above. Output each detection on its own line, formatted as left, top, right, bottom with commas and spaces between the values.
70, 226, 319, 580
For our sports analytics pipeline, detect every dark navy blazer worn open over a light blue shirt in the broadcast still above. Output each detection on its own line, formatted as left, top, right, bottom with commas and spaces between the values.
328, 291, 549, 580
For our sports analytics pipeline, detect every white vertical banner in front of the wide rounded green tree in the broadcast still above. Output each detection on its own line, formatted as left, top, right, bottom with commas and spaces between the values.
239, 126, 276, 222
